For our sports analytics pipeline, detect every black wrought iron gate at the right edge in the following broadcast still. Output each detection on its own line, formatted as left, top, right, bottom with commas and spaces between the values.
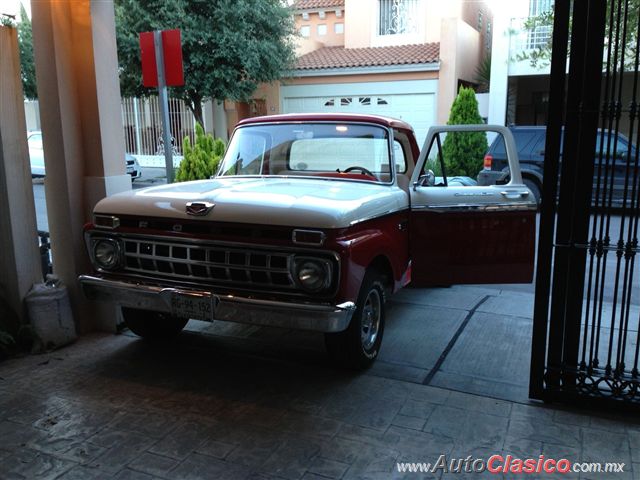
530, 0, 640, 407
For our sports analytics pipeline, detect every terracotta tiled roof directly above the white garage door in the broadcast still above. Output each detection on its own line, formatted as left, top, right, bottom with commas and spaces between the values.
295, 42, 440, 70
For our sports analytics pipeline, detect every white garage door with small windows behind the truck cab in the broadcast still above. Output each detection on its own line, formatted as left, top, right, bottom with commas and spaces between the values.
281, 80, 436, 147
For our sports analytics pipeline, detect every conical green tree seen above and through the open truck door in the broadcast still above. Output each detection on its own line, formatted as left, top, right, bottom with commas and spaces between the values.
442, 87, 489, 177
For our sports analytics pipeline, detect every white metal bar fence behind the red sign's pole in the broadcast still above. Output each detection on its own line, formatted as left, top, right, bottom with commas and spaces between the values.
122, 96, 196, 155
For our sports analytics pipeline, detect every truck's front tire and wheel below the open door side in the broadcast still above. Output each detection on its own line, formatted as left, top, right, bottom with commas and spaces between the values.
325, 270, 386, 369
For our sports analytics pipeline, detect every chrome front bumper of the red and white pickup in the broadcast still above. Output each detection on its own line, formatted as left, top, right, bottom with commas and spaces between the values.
78, 275, 356, 332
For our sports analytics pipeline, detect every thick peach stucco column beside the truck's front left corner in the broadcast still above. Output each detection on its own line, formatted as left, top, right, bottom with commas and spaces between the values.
31, 0, 131, 332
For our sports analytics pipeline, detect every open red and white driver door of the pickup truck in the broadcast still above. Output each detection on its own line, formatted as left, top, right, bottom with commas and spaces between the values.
410, 125, 537, 286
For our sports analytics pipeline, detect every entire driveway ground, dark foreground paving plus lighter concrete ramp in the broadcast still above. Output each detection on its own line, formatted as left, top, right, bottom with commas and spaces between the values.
0, 287, 640, 480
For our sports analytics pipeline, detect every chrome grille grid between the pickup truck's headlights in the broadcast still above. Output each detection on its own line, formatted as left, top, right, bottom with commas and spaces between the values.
123, 238, 296, 289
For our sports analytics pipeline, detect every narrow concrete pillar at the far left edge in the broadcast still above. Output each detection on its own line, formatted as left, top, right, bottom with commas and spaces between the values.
0, 26, 42, 323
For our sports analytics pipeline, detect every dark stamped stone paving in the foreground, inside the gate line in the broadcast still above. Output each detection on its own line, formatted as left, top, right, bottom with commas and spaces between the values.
0, 332, 640, 480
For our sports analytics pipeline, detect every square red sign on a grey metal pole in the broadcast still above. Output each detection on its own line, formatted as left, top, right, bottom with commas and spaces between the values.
140, 30, 184, 87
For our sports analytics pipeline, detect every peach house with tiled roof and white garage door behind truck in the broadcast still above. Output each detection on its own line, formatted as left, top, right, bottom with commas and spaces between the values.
225, 0, 492, 146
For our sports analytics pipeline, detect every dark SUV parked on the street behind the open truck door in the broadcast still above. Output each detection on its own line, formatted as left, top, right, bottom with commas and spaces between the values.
478, 126, 636, 205
